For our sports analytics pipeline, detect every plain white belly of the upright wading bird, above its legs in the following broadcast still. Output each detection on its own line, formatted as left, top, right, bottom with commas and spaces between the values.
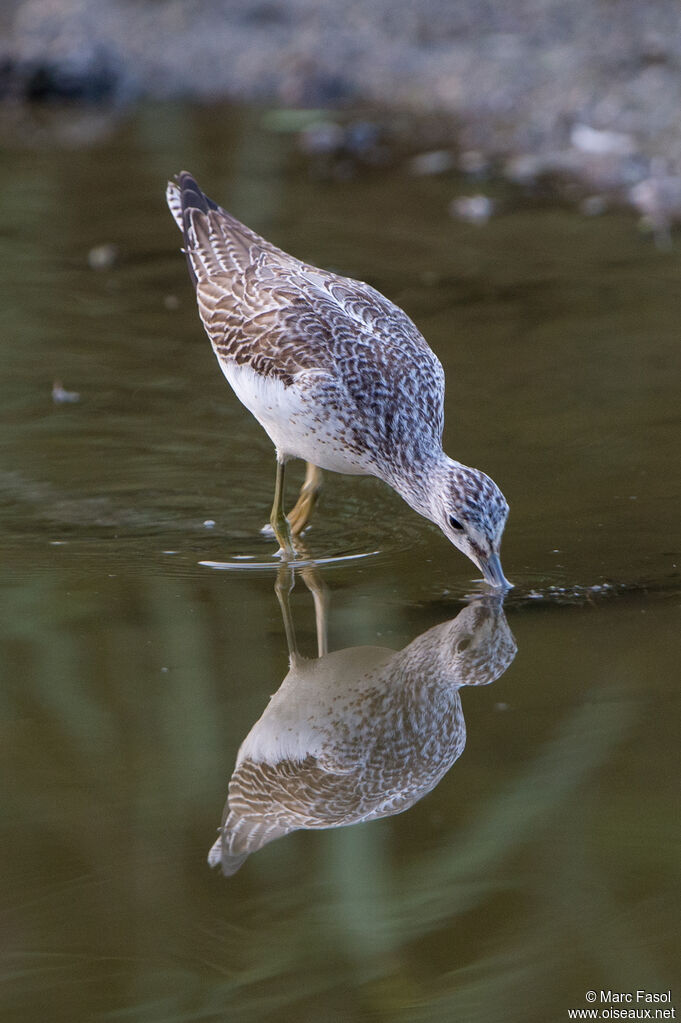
219, 360, 374, 476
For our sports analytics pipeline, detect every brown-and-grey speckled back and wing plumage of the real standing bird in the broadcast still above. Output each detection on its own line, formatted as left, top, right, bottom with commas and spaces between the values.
169, 174, 445, 479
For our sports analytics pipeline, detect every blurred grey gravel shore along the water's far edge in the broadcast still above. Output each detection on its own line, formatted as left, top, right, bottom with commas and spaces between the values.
0, 0, 681, 221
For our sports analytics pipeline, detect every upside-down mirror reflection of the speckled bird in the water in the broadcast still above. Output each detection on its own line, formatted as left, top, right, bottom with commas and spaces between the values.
209, 598, 515, 875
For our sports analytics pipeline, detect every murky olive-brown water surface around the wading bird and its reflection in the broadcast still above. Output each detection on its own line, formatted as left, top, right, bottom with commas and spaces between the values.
0, 107, 681, 1023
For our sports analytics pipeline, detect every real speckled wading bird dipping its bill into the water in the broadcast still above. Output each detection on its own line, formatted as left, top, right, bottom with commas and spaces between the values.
167, 172, 508, 586
